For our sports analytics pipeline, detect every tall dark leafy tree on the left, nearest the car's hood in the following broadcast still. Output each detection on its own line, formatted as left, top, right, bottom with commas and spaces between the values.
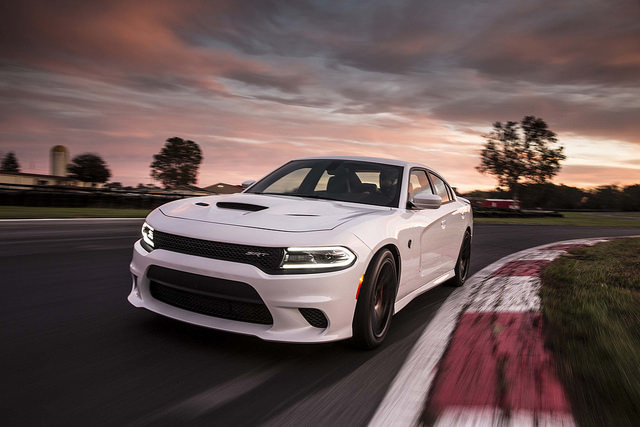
150, 136, 202, 188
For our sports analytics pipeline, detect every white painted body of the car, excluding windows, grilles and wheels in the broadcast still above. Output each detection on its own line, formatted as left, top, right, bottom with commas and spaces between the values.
128, 157, 473, 342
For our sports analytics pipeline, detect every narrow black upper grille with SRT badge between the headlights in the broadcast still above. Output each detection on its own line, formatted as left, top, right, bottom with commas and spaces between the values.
153, 231, 284, 272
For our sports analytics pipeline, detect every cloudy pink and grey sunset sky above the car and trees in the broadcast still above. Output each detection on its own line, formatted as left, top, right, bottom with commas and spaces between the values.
0, 0, 640, 191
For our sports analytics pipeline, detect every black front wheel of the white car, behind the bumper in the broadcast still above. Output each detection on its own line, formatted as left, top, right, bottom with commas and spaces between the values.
352, 249, 398, 350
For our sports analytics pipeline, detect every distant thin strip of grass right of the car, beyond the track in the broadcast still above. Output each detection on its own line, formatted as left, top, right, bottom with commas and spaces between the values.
473, 212, 640, 228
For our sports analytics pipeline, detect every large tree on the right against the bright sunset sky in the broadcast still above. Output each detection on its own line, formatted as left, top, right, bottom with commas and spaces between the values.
476, 116, 566, 198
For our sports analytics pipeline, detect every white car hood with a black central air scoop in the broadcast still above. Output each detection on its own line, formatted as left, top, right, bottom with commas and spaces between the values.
160, 193, 380, 232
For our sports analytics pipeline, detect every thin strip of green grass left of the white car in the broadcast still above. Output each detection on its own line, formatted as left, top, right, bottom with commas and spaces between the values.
0, 206, 150, 219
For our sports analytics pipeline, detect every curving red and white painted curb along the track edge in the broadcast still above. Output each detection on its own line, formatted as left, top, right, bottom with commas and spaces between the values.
369, 238, 620, 426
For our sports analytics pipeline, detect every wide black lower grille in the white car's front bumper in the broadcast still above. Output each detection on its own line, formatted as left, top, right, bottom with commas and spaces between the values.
147, 265, 273, 325
